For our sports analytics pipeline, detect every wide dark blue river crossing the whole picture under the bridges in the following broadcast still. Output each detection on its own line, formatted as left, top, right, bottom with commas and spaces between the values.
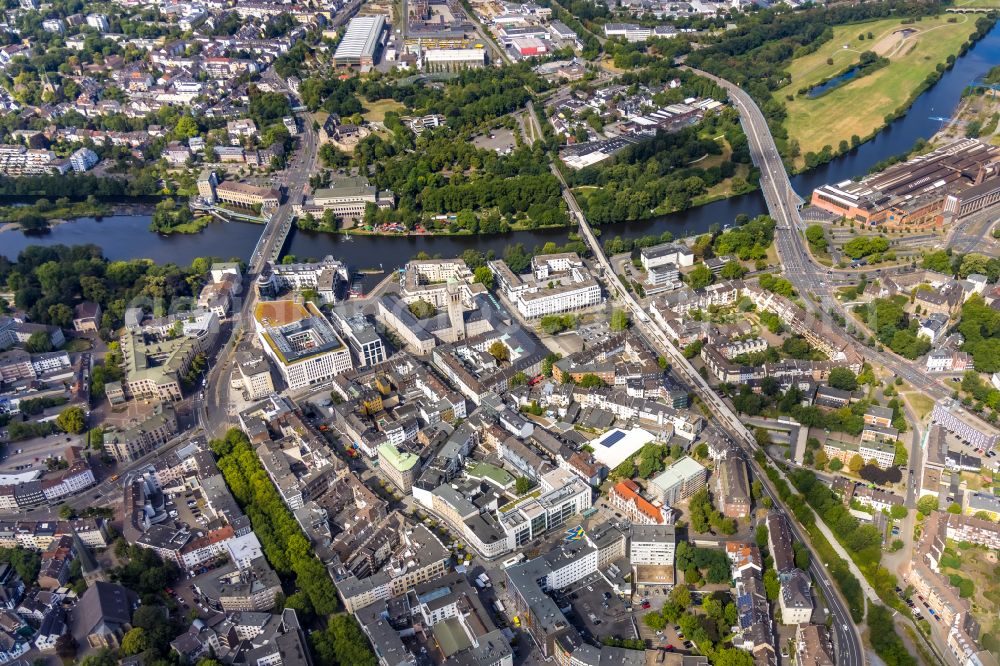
0, 24, 1000, 269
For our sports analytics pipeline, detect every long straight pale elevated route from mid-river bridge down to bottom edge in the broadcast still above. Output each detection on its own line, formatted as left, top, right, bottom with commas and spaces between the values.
552, 161, 865, 666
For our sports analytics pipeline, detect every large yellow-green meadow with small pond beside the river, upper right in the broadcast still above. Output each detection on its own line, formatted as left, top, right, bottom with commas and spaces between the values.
774, 13, 984, 166
